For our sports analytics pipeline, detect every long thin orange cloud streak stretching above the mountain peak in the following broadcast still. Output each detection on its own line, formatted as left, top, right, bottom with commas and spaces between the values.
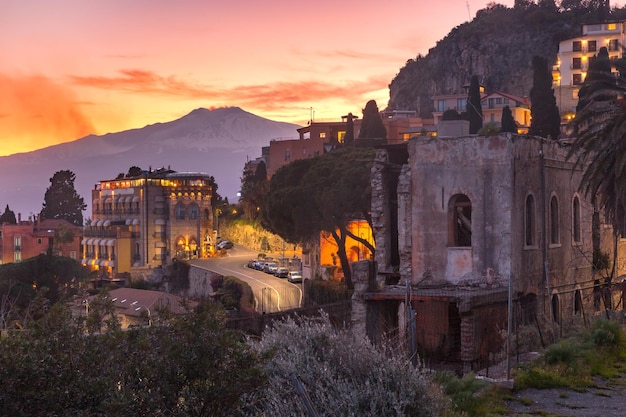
70, 69, 389, 111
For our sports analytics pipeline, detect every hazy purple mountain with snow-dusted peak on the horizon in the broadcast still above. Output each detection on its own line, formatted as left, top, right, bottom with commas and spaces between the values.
0, 107, 300, 219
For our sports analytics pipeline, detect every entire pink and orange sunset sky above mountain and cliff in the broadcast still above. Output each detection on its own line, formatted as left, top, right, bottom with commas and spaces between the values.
0, 0, 513, 156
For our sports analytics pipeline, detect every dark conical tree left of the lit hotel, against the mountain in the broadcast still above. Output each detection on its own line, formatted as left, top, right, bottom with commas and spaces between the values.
40, 170, 87, 226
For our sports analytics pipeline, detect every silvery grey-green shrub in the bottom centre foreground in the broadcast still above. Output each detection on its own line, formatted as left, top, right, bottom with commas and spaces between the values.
247, 316, 447, 417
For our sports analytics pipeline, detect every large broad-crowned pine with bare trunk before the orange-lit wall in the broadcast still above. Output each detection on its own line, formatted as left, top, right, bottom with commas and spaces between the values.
262, 147, 375, 288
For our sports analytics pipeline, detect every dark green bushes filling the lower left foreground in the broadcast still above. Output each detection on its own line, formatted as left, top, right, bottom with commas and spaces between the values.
0, 304, 265, 417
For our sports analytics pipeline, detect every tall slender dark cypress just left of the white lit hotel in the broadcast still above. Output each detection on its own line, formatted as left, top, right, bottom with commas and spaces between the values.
528, 55, 561, 140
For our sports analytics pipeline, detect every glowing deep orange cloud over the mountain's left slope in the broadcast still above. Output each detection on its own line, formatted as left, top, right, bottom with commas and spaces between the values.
0, 74, 95, 155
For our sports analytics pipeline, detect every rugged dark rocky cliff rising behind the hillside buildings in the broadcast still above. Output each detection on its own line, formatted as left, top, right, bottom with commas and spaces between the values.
387, 5, 624, 117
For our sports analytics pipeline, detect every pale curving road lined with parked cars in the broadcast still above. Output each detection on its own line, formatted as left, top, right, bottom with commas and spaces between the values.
189, 244, 302, 313
